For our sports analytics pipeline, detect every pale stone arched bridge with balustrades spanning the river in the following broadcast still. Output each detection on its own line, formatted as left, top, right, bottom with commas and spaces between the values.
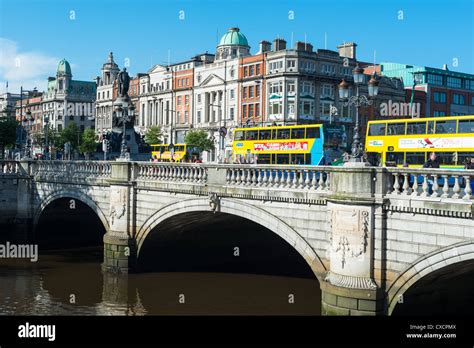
0, 161, 474, 315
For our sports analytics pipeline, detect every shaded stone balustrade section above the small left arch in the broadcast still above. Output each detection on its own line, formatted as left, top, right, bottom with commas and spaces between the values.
30, 161, 112, 178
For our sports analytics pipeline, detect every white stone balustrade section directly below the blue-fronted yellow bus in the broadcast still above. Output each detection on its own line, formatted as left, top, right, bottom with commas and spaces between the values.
226, 165, 334, 192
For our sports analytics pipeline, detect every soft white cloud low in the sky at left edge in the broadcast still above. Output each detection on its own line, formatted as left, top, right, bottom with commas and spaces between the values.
0, 37, 59, 93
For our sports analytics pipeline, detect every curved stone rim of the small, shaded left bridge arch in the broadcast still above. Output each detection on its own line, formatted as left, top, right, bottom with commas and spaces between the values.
33, 189, 109, 231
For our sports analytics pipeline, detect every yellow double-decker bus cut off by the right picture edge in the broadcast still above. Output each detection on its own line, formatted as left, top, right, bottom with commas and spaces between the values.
365, 115, 474, 169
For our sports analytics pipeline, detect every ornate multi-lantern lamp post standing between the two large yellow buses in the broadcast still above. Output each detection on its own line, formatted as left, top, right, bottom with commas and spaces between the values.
339, 64, 379, 163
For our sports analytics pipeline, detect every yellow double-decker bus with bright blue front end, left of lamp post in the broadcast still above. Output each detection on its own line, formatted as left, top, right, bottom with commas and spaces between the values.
232, 124, 324, 165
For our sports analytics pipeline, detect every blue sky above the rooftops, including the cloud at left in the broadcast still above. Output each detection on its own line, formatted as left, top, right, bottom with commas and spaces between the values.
0, 0, 474, 92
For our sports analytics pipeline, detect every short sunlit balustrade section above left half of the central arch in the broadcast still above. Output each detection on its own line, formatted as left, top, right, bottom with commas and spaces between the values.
132, 162, 207, 183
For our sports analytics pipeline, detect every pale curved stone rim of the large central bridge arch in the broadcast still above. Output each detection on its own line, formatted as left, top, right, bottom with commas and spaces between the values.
136, 198, 327, 282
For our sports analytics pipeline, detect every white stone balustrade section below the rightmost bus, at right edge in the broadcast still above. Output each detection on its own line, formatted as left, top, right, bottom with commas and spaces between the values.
387, 168, 474, 200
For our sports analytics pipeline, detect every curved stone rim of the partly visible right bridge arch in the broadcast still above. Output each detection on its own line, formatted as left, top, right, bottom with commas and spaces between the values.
387, 241, 474, 315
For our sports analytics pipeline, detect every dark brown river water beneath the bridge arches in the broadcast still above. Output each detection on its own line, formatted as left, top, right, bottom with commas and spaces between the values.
0, 247, 321, 315
